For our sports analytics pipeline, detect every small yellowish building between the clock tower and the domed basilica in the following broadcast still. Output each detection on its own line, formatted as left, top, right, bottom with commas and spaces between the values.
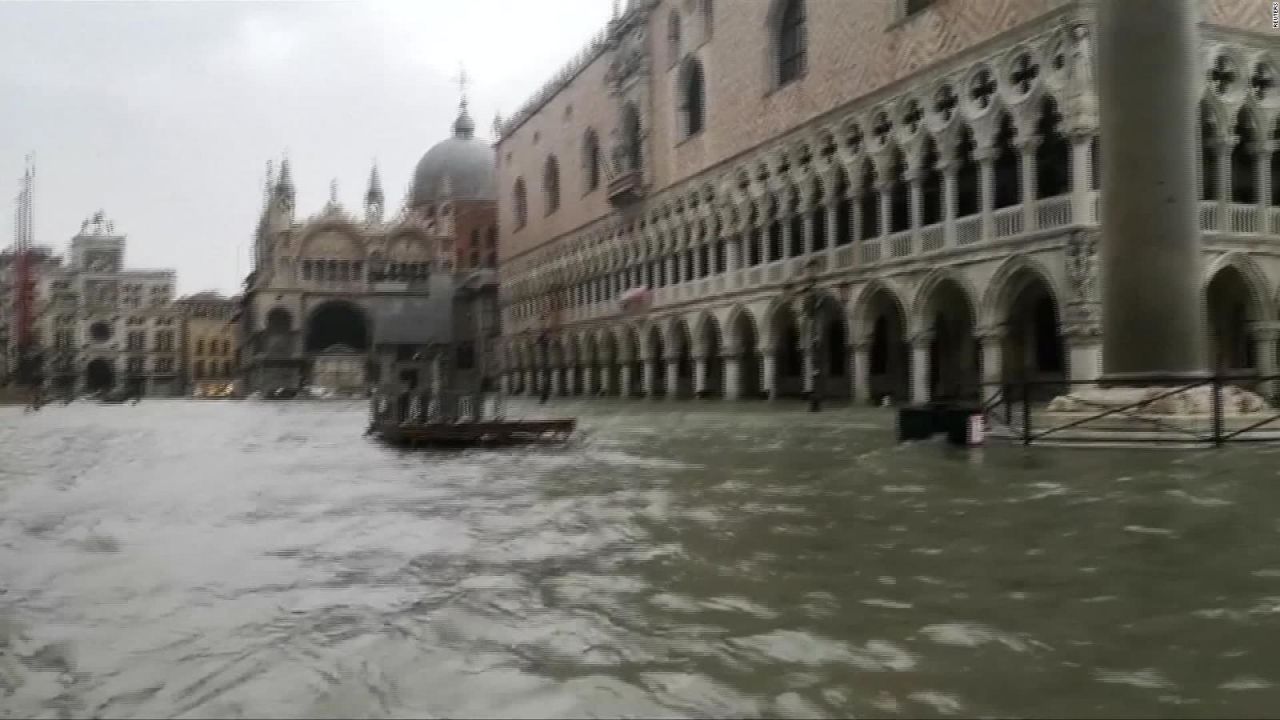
174, 292, 241, 396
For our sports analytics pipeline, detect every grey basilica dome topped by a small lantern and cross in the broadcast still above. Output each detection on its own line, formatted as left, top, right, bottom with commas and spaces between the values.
408, 104, 498, 208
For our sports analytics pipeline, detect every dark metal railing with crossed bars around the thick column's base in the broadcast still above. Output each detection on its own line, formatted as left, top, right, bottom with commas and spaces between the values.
978, 373, 1280, 447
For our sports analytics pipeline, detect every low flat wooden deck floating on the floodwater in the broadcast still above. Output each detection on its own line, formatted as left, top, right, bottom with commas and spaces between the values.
370, 418, 577, 447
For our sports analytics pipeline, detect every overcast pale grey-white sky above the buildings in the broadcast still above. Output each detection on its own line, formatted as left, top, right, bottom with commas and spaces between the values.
0, 0, 612, 293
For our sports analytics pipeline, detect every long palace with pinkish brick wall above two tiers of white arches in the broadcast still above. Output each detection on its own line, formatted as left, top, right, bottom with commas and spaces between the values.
497, 0, 1280, 402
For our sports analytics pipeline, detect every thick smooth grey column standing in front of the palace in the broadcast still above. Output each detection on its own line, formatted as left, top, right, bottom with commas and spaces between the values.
1097, 0, 1208, 386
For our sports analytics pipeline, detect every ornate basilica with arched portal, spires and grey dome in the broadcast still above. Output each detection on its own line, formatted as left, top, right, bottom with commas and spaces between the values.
239, 100, 498, 392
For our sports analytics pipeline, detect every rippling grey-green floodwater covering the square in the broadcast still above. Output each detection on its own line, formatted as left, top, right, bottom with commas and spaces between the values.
0, 401, 1280, 717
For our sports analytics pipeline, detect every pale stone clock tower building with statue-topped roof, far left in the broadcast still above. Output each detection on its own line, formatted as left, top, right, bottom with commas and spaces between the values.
36, 211, 182, 396
